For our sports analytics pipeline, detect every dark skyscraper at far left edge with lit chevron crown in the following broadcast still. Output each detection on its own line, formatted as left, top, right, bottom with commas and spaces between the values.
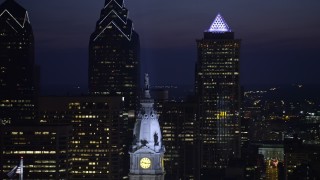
0, 0, 35, 125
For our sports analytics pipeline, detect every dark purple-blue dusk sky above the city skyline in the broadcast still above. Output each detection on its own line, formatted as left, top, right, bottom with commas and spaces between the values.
6, 0, 320, 94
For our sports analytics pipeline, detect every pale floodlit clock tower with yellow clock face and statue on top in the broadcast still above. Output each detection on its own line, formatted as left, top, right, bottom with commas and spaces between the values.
129, 74, 165, 180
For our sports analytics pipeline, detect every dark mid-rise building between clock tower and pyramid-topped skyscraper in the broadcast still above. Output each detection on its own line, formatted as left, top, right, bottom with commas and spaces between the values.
159, 101, 199, 179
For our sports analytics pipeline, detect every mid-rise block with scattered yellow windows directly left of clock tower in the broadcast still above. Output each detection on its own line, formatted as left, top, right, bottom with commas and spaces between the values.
39, 96, 128, 179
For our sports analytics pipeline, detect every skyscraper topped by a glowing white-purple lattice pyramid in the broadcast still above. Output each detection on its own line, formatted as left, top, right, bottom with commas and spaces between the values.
195, 14, 241, 169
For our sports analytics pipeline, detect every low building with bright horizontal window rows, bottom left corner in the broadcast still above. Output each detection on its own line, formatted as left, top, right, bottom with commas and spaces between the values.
0, 125, 72, 179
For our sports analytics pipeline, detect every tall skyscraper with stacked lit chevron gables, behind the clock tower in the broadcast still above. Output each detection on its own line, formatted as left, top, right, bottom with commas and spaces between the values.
89, 0, 140, 110
